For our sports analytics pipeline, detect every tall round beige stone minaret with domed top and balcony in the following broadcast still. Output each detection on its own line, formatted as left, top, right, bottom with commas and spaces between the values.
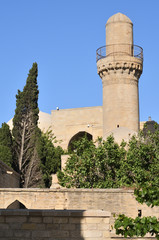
97, 13, 143, 141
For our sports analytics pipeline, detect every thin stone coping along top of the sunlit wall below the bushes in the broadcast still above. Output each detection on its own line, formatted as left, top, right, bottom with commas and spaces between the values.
0, 188, 134, 193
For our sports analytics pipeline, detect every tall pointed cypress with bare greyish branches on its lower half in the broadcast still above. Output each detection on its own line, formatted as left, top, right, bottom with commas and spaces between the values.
12, 63, 41, 188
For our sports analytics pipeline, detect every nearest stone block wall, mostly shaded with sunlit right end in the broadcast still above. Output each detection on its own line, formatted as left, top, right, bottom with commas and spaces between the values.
0, 210, 110, 240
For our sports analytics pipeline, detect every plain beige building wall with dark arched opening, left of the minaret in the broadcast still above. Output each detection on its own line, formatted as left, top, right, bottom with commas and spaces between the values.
51, 106, 103, 149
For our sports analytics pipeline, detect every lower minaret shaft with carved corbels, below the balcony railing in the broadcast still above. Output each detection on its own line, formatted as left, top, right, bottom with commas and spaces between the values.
97, 56, 142, 141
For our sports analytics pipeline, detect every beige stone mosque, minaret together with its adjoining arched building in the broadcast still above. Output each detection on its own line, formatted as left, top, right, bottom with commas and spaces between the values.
9, 13, 143, 149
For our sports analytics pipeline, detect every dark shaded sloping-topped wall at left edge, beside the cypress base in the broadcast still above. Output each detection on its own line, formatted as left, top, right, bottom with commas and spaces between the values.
0, 161, 20, 188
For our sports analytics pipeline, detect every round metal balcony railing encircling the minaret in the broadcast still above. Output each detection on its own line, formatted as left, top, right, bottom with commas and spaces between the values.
96, 44, 143, 61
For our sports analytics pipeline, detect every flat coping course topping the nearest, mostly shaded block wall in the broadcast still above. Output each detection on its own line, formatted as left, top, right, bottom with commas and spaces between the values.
0, 209, 111, 217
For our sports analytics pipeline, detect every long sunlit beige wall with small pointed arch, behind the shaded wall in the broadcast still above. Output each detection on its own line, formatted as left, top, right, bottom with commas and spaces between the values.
0, 188, 159, 220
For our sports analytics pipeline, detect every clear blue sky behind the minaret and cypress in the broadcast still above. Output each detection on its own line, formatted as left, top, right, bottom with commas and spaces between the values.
0, 0, 159, 124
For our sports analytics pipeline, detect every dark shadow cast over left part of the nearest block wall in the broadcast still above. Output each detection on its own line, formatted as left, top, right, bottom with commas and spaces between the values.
0, 209, 87, 240
